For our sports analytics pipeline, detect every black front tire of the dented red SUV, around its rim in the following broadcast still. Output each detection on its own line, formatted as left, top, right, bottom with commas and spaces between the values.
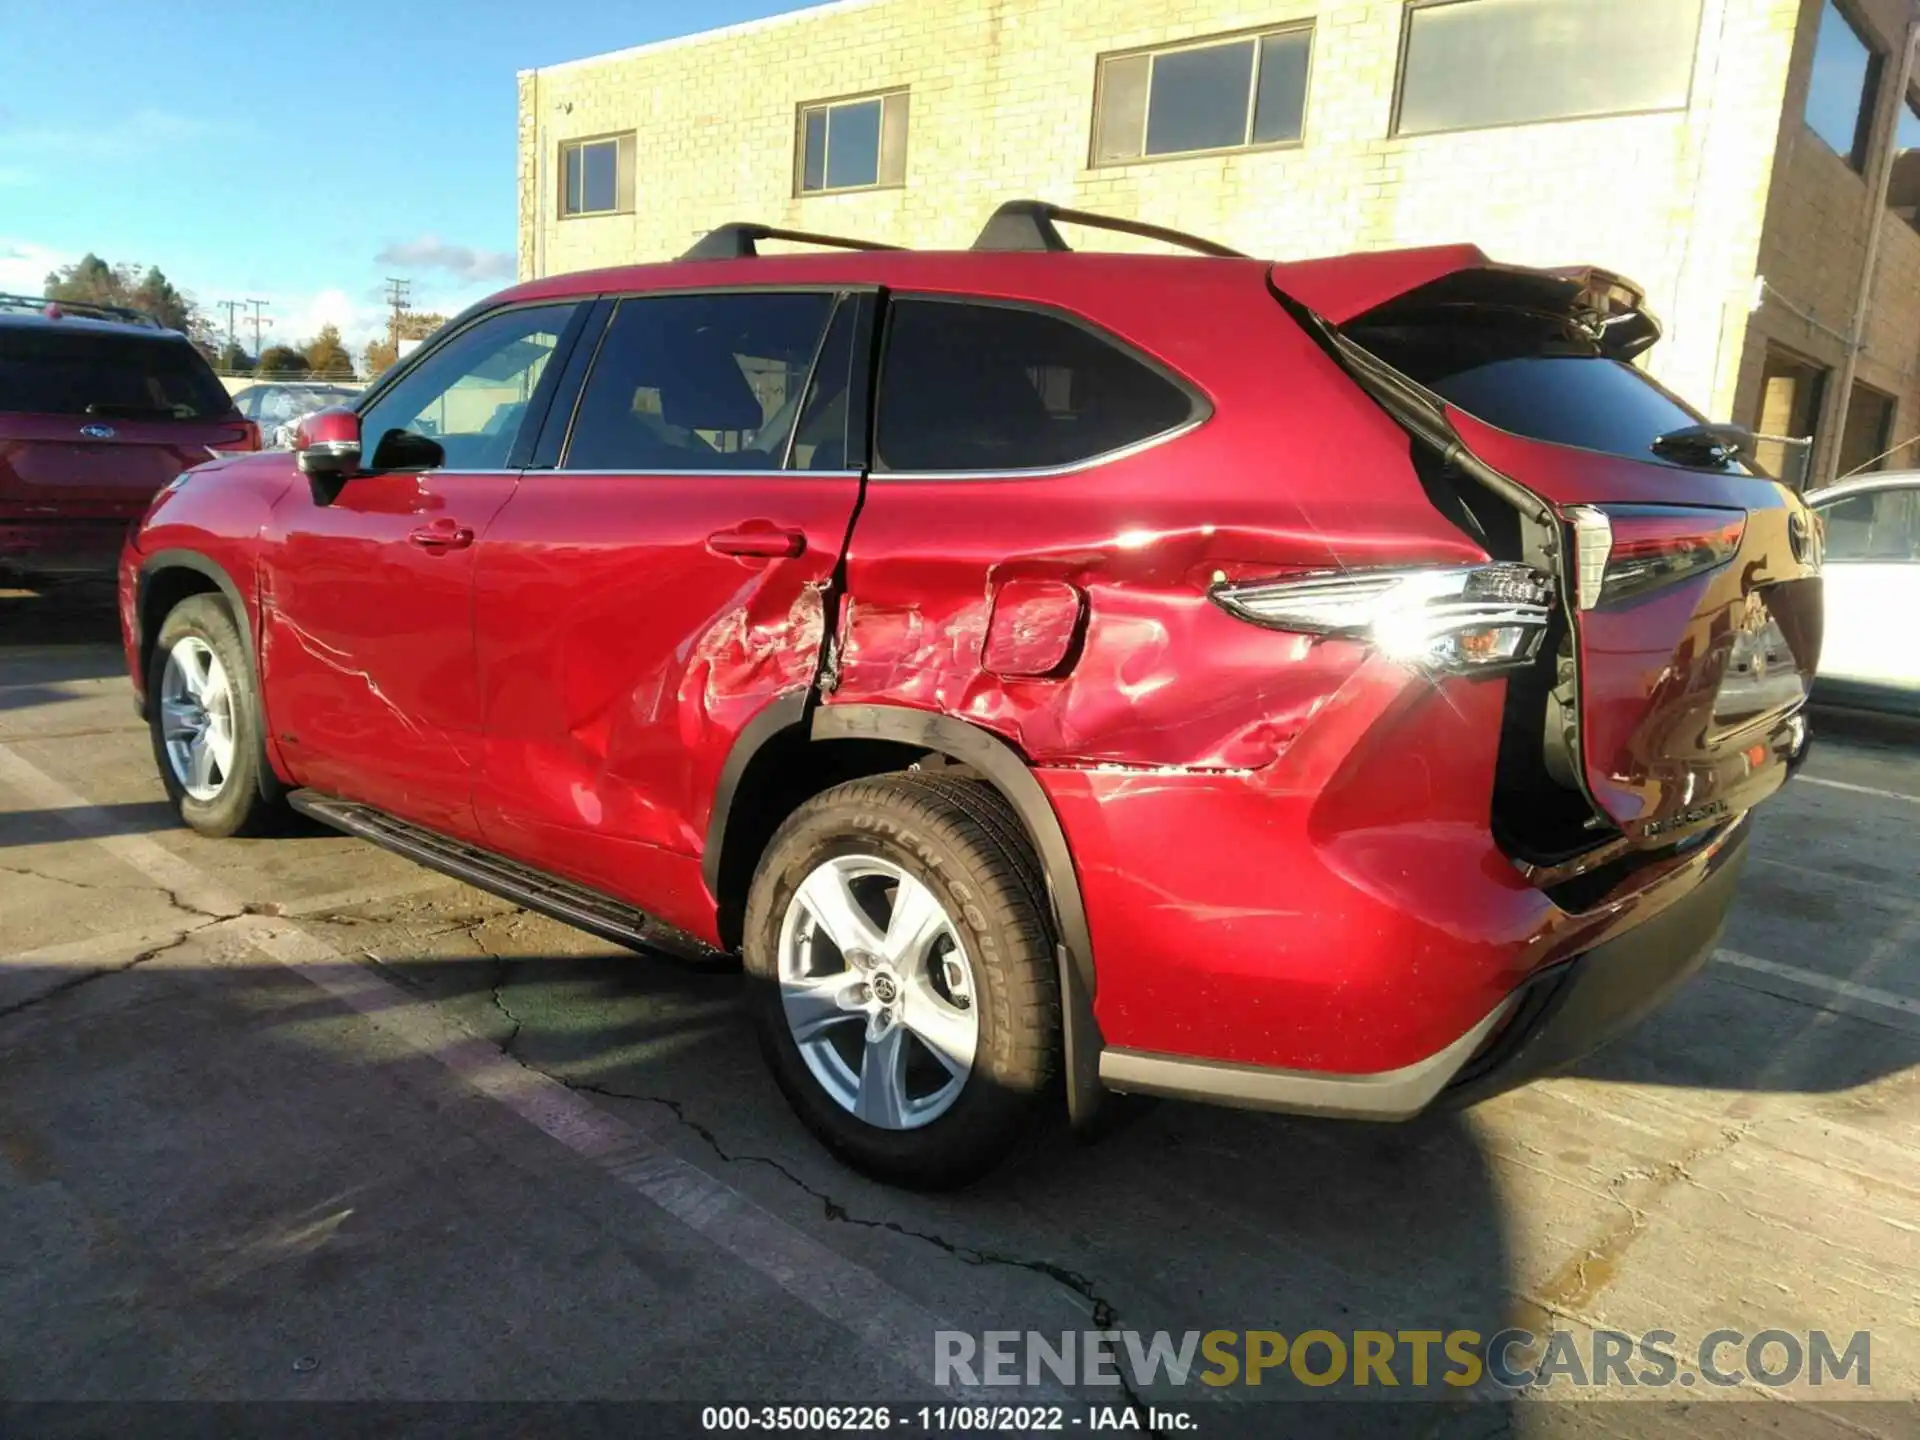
146, 595, 286, 837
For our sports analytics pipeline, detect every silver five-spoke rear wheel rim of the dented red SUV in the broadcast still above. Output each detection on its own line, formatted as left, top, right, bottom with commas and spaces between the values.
780, 854, 979, 1131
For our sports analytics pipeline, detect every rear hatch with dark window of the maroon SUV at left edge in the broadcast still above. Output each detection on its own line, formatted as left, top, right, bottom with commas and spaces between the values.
0, 319, 257, 522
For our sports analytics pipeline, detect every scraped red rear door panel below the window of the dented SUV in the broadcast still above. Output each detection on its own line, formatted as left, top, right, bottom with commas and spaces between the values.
474, 472, 860, 939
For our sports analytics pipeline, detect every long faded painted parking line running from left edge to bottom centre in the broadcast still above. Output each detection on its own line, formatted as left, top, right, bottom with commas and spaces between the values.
0, 745, 1036, 1404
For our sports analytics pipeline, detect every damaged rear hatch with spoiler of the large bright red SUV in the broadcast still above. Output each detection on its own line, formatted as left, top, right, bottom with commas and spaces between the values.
1273, 248, 1820, 883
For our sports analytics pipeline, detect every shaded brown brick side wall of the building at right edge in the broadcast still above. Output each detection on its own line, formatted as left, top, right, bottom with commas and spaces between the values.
1734, 0, 1920, 478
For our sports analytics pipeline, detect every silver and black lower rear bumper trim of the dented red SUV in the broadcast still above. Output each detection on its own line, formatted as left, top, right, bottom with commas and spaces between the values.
1100, 820, 1747, 1119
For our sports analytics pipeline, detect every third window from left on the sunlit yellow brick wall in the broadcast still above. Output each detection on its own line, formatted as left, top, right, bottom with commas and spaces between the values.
1092, 25, 1313, 165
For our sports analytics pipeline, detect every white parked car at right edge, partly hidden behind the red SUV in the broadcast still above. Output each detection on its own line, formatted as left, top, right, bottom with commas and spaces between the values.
1807, 470, 1920, 712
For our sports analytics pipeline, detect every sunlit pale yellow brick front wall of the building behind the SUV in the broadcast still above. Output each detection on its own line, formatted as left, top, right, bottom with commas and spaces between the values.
520, 0, 1820, 422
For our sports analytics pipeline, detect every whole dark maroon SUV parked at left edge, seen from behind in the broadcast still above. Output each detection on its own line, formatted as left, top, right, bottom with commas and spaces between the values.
0, 296, 259, 586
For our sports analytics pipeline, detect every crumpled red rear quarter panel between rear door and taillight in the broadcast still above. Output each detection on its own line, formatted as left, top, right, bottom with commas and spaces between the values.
831, 261, 1484, 770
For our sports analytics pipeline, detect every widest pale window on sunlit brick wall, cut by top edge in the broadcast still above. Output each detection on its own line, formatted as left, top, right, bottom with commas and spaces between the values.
1394, 0, 1699, 134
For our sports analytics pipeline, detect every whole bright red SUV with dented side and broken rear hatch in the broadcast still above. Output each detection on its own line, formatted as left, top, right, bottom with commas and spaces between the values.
121, 202, 1820, 1185
